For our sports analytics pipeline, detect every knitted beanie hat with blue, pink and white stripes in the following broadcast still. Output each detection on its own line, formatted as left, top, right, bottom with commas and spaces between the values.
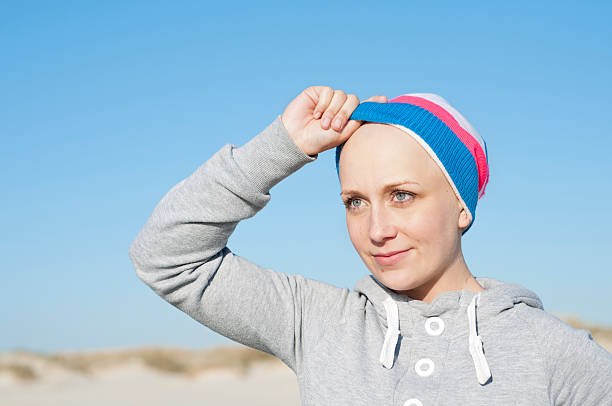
336, 93, 489, 234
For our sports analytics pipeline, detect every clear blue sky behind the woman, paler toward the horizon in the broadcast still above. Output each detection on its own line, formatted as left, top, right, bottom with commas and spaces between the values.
0, 1, 612, 351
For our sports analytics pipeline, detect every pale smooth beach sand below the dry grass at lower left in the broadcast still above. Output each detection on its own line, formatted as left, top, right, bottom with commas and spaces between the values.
0, 353, 300, 406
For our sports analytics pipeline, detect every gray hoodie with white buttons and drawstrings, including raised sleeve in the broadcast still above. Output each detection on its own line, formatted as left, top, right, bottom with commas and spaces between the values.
129, 116, 612, 406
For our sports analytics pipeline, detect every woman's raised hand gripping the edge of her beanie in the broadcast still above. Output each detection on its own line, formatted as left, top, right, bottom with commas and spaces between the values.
281, 86, 387, 156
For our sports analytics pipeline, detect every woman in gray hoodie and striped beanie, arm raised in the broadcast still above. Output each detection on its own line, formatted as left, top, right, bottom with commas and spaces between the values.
130, 86, 612, 406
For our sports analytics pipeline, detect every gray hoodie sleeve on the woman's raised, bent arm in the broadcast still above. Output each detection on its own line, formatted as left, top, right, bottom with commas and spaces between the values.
129, 115, 346, 371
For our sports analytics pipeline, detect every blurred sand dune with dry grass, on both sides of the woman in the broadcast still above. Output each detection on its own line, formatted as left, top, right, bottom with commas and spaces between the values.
0, 317, 612, 406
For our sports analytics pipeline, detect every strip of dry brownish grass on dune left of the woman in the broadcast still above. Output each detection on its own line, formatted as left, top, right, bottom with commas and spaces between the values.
0, 347, 279, 380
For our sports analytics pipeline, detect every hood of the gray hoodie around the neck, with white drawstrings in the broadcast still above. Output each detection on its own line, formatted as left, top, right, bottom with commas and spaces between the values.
354, 275, 544, 385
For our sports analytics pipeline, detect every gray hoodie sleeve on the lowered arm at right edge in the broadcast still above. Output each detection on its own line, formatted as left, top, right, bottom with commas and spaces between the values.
542, 321, 612, 406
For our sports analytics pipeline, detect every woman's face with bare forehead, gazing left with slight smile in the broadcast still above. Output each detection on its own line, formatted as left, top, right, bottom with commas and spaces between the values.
339, 123, 469, 297
